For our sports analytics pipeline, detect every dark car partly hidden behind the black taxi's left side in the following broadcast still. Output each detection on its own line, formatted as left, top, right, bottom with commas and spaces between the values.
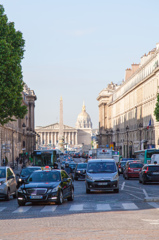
17, 166, 41, 188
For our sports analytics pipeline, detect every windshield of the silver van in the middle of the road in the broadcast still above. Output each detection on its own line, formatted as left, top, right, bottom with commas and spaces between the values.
88, 162, 117, 173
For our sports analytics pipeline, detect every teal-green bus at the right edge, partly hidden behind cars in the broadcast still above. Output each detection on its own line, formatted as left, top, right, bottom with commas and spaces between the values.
134, 148, 159, 164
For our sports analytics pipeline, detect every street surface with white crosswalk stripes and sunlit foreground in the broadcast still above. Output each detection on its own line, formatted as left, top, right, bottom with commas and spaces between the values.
0, 158, 159, 240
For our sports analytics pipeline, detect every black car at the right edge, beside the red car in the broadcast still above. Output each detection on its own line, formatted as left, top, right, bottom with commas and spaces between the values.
139, 164, 159, 184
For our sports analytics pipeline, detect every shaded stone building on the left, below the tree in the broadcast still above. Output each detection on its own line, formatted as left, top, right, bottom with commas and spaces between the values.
0, 84, 36, 166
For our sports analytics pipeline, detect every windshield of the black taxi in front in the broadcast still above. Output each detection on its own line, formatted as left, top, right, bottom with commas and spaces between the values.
28, 171, 61, 182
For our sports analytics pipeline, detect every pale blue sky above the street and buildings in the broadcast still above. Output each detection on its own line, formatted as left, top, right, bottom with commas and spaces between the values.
0, 0, 159, 128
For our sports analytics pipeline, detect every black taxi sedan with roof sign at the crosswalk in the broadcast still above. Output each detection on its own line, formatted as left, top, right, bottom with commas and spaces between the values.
17, 170, 74, 206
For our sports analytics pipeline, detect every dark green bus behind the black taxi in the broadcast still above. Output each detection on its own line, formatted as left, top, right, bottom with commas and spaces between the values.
33, 149, 59, 169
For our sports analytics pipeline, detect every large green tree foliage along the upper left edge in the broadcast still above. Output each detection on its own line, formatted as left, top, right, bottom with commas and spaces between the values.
0, 5, 27, 125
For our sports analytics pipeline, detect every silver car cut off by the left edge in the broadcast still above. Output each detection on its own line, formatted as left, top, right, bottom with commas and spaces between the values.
0, 166, 17, 201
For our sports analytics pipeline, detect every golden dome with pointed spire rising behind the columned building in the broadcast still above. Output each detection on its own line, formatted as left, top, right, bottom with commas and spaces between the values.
76, 103, 92, 129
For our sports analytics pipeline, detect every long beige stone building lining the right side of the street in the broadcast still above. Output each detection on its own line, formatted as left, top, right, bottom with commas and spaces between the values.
97, 43, 159, 157
